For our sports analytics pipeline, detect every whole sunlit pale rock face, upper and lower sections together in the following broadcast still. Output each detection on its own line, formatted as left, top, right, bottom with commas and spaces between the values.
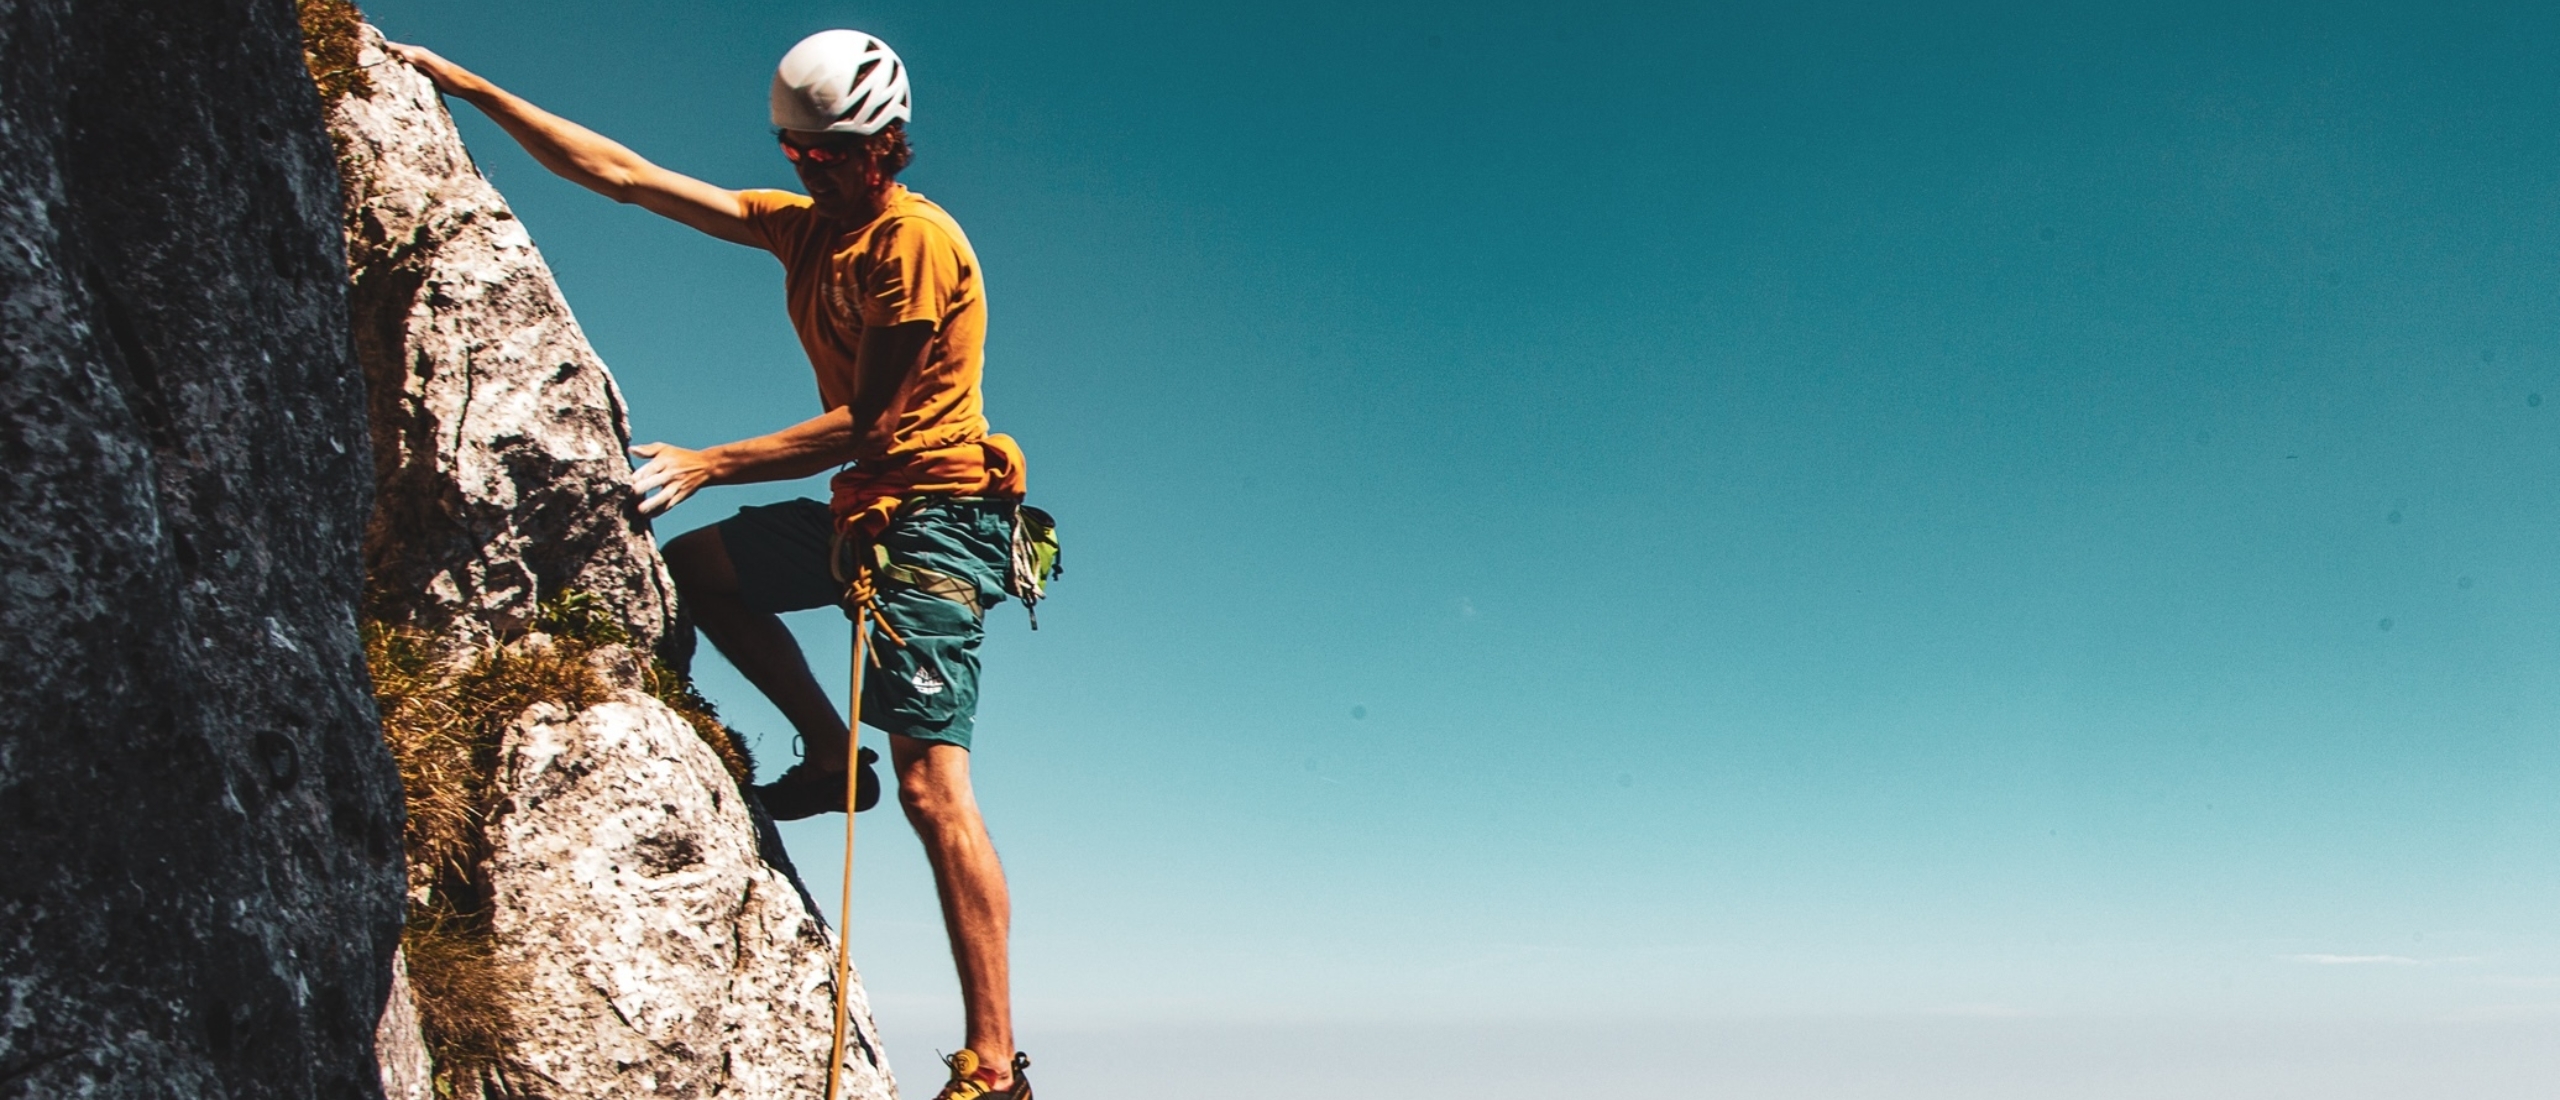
330, 28, 896, 1100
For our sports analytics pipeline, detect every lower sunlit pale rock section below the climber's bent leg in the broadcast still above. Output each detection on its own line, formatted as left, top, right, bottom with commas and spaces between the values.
489, 660, 893, 1100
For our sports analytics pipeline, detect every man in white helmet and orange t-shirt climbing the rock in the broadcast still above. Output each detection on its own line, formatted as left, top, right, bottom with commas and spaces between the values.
392, 31, 1032, 1100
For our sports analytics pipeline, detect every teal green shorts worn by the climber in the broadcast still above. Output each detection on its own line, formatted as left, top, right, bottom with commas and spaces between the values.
717, 496, 1014, 750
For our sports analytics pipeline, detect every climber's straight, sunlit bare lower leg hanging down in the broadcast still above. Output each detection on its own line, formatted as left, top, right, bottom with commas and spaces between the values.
888, 734, 1014, 1090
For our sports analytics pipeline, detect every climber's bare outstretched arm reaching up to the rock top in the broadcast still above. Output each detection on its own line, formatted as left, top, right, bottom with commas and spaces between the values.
389, 43, 755, 246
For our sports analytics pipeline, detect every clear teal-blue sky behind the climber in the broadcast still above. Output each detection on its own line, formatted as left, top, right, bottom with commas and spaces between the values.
369, 0, 2560, 1097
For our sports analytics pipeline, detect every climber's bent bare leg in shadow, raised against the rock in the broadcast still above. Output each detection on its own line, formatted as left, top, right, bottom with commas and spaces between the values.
666, 527, 845, 773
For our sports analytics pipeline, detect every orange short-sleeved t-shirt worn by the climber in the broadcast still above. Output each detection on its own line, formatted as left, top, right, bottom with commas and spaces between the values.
737, 184, 1024, 535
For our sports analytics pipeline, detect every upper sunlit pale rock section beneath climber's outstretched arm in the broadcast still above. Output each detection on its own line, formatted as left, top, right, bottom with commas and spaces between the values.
330, 28, 689, 660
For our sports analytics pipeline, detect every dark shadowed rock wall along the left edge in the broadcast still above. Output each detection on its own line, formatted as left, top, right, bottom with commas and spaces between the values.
0, 0, 402, 1097
